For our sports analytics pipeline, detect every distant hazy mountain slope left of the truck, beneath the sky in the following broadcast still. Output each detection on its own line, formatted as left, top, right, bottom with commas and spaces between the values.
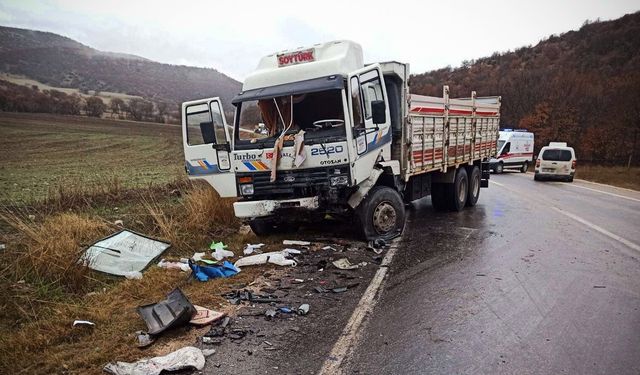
0, 26, 241, 109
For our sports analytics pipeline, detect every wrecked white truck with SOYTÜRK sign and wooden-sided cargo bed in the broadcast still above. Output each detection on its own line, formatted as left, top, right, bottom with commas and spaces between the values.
182, 41, 500, 239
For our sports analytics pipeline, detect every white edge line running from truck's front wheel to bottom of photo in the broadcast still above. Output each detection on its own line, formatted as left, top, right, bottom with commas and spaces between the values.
318, 237, 401, 375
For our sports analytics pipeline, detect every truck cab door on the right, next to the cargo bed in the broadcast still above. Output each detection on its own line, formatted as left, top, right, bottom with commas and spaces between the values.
349, 64, 391, 183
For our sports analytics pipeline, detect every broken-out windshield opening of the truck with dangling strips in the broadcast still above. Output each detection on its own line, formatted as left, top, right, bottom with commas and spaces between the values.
235, 90, 345, 144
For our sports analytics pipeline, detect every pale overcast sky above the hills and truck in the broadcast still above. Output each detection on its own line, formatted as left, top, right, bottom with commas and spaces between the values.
0, 0, 640, 80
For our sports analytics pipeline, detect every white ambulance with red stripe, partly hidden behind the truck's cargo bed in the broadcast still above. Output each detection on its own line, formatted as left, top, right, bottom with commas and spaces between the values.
490, 129, 533, 173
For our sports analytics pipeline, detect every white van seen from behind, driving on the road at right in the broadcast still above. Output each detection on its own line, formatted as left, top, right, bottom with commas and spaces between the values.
533, 142, 577, 182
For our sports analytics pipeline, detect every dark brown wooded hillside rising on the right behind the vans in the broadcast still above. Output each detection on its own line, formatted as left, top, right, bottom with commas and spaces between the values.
411, 12, 640, 163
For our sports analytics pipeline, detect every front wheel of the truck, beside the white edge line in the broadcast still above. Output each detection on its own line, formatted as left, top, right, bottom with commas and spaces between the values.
356, 186, 405, 240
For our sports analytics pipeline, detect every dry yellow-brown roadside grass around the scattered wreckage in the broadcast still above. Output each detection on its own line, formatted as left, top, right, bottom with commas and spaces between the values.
0, 183, 269, 374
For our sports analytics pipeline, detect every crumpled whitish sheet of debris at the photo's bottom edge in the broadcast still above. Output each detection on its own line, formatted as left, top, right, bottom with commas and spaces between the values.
103, 346, 215, 375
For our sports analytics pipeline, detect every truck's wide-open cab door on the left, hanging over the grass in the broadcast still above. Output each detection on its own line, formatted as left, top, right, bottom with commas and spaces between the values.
182, 98, 237, 197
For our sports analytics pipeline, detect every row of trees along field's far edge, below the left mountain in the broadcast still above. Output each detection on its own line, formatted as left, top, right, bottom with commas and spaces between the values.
0, 80, 180, 123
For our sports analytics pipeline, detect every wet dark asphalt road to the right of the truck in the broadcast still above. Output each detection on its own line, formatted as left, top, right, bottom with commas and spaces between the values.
342, 173, 640, 374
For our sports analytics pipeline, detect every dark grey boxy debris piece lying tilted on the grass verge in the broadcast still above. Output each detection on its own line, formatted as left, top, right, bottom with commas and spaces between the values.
138, 288, 196, 335
